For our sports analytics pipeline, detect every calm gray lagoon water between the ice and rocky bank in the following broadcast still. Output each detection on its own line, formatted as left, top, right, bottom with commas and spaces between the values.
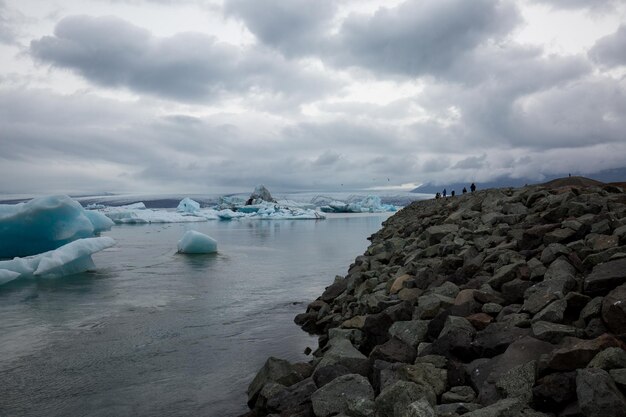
0, 214, 388, 417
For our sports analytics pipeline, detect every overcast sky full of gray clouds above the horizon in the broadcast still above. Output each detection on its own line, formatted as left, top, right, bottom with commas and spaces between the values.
0, 0, 626, 194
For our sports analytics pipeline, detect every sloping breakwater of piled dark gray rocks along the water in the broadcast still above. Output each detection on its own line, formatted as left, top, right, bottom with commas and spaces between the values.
236, 178, 626, 417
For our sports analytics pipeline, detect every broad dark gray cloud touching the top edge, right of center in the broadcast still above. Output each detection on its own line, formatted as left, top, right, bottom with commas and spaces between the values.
334, 0, 520, 76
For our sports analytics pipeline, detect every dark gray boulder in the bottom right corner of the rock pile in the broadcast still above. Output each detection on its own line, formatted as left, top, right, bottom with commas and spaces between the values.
576, 368, 626, 417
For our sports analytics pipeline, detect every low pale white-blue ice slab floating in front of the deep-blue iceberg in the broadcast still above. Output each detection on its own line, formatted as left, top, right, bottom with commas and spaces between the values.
0, 237, 115, 285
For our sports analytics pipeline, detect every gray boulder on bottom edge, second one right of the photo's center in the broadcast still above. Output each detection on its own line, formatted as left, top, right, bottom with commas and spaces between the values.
376, 381, 433, 417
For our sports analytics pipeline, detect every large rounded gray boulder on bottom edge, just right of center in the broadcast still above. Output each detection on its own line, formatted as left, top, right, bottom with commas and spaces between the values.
311, 374, 374, 417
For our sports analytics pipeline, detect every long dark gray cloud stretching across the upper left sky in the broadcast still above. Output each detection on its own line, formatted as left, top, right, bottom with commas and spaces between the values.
30, 16, 333, 101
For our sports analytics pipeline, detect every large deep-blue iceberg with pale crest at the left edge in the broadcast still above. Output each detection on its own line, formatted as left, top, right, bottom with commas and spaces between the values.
0, 196, 113, 258
